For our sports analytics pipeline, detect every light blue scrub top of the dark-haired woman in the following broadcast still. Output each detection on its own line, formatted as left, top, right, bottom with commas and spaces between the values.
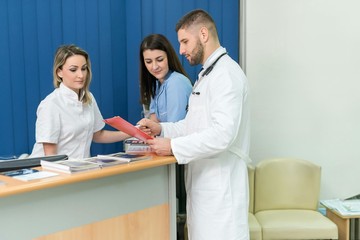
149, 72, 192, 122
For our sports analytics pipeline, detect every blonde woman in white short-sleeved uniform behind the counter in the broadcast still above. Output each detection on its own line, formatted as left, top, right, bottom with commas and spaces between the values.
31, 45, 130, 158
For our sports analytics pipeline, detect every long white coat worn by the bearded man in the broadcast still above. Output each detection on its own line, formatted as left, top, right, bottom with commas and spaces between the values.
162, 47, 250, 240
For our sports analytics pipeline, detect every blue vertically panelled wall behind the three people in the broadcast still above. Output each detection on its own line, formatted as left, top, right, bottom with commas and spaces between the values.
0, 0, 239, 157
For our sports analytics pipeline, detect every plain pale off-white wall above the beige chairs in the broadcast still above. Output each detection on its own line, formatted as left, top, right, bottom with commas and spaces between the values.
242, 0, 360, 199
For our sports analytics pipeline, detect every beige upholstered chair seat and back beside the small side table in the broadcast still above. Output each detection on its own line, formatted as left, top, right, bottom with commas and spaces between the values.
254, 158, 338, 240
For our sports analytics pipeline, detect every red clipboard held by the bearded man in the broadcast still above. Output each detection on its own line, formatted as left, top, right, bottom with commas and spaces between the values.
104, 116, 153, 141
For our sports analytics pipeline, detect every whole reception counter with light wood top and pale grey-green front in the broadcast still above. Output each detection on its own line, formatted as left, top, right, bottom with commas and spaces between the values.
0, 156, 176, 240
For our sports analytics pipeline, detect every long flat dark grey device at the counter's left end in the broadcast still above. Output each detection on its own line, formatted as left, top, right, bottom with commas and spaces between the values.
0, 155, 68, 172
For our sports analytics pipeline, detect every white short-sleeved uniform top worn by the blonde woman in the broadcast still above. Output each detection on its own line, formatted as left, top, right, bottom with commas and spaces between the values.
30, 84, 105, 158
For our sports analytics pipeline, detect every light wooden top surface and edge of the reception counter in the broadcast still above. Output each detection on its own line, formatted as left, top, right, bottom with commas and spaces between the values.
0, 155, 176, 197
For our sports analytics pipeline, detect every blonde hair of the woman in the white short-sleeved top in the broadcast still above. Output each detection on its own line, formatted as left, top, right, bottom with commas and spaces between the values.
53, 44, 92, 104
